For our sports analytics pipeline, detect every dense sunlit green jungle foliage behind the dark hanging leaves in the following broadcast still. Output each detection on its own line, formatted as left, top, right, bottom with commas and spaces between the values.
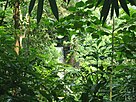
0, 0, 136, 102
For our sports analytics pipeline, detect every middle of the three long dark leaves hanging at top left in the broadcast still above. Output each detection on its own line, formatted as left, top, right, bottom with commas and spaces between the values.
37, 0, 44, 23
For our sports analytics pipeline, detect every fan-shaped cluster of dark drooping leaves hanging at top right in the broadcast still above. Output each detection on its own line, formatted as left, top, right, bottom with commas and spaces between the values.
96, 0, 136, 23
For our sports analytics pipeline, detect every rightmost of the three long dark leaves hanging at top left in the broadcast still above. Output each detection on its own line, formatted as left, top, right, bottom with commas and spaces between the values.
49, 0, 59, 20
